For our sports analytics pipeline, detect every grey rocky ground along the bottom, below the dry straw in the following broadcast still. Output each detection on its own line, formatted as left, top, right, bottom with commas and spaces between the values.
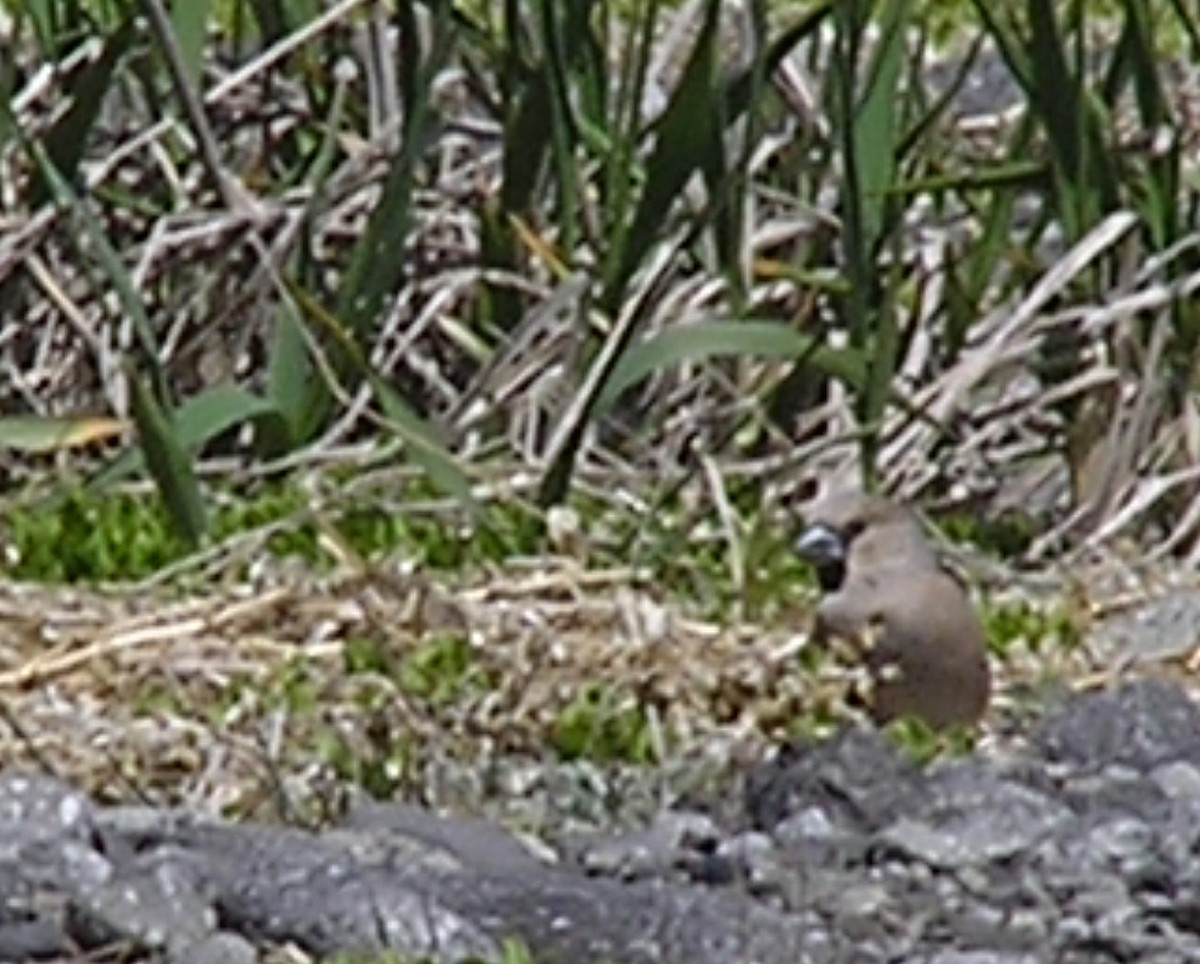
7, 681, 1200, 964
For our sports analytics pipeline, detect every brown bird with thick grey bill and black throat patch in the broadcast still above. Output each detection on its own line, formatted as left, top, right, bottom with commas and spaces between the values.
796, 491, 991, 728
